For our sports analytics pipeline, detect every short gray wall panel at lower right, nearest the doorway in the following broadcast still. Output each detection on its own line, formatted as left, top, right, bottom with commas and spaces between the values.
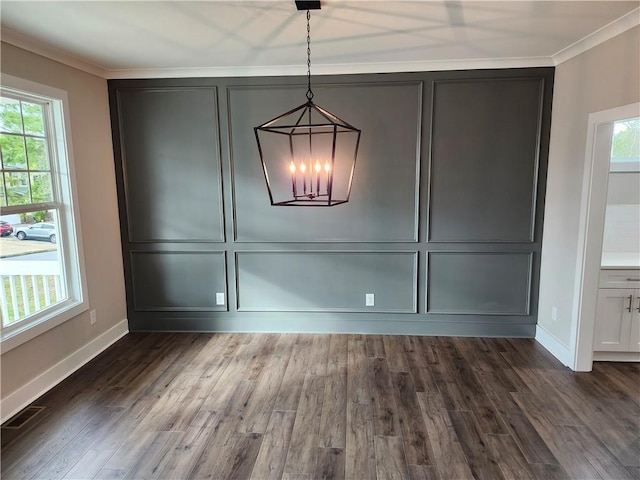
426, 251, 533, 316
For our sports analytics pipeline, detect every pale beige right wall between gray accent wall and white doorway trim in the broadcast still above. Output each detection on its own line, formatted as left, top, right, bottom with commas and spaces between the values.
538, 27, 640, 348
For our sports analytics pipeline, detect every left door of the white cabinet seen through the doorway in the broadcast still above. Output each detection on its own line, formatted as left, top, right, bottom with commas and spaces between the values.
593, 288, 635, 352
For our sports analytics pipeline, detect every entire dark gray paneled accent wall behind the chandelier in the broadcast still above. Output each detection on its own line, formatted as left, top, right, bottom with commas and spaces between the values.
109, 68, 553, 336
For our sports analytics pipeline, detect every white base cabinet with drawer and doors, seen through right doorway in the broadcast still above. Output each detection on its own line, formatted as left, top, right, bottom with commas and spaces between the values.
593, 270, 640, 352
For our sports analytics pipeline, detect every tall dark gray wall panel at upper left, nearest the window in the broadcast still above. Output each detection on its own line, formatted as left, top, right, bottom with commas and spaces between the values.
118, 88, 224, 242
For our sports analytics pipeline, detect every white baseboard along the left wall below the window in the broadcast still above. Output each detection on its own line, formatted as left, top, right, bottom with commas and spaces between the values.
0, 319, 129, 423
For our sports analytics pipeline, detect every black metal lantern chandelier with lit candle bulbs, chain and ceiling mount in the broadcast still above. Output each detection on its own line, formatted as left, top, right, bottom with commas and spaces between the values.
254, 1, 360, 207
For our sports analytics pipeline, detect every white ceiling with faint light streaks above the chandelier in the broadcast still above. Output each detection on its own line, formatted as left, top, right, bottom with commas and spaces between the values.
0, 0, 640, 78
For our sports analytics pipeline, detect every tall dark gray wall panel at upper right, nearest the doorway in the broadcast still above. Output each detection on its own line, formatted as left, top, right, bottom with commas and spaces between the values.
429, 78, 543, 242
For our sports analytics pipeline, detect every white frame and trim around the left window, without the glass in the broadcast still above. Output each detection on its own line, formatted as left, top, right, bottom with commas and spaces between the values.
0, 73, 89, 353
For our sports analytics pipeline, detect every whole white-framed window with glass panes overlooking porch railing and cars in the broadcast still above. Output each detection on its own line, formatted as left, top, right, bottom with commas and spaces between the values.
0, 75, 88, 352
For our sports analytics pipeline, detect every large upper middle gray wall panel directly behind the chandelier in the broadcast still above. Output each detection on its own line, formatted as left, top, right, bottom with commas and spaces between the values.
227, 81, 423, 244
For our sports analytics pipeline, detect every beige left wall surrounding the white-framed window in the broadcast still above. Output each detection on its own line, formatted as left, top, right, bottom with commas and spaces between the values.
0, 43, 126, 404
